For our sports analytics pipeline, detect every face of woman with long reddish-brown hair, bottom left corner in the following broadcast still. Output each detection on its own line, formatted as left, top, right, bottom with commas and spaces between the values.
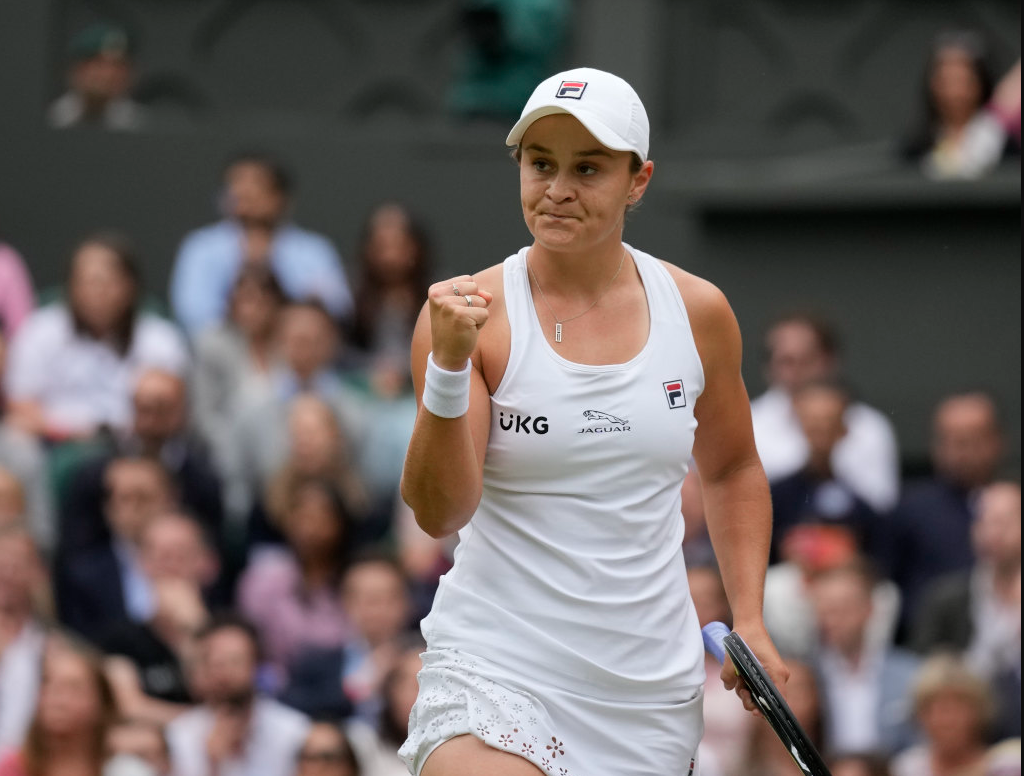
36, 642, 112, 740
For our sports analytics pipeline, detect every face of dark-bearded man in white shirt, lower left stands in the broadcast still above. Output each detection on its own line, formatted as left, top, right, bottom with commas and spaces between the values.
198, 626, 258, 706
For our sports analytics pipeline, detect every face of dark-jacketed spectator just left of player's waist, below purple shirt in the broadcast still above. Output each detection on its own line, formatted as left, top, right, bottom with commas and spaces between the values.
342, 561, 411, 645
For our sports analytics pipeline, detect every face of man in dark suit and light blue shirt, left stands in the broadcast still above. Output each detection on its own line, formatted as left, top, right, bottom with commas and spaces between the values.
103, 458, 173, 543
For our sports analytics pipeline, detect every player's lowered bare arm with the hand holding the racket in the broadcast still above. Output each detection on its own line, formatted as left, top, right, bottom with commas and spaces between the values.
677, 273, 788, 710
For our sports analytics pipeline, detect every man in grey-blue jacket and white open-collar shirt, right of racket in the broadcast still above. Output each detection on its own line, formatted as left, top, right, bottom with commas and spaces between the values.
811, 562, 918, 755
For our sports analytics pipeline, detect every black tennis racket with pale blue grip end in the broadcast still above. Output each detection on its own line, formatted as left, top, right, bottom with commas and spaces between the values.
700, 622, 831, 776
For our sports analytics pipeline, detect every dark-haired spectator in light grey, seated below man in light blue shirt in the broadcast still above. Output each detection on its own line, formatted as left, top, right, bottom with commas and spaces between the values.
193, 264, 285, 475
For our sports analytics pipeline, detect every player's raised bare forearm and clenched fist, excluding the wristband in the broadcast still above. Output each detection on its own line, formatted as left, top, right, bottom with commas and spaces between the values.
401, 275, 492, 538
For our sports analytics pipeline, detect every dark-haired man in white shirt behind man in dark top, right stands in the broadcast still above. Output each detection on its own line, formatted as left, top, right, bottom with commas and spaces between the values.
751, 313, 899, 520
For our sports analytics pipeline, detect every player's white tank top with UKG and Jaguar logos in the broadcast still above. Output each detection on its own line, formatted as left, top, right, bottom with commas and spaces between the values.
423, 248, 705, 701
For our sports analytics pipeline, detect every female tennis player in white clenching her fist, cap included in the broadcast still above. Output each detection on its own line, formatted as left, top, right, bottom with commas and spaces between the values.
400, 69, 786, 776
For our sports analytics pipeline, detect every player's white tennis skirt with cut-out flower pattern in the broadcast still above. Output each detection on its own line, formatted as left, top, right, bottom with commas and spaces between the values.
398, 649, 703, 776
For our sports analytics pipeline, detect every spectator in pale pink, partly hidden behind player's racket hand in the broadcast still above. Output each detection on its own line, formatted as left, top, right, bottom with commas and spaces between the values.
686, 563, 757, 774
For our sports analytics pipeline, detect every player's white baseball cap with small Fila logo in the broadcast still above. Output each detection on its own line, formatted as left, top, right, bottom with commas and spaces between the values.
505, 68, 650, 162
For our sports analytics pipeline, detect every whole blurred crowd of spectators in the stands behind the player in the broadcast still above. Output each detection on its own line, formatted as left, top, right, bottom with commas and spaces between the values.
0, 13, 1021, 776
